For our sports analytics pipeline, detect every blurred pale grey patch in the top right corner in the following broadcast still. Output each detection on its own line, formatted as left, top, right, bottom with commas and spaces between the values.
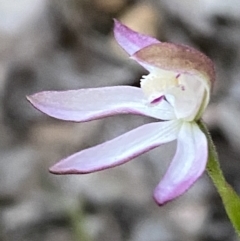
155, 0, 240, 36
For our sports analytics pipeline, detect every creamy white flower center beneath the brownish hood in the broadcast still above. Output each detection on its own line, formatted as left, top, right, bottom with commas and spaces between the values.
141, 69, 205, 121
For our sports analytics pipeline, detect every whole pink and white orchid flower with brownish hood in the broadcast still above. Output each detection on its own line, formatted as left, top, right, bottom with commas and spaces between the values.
28, 20, 215, 205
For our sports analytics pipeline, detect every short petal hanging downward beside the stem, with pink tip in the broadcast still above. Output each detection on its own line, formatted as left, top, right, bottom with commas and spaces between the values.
154, 123, 208, 205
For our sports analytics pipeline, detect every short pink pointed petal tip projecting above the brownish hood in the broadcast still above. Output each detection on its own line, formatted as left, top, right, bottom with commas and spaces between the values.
114, 19, 160, 55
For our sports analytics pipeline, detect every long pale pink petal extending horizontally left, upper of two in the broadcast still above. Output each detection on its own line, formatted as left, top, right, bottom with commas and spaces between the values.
27, 86, 175, 122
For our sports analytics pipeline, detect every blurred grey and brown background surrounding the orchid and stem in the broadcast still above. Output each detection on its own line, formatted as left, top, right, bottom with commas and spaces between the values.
0, 0, 240, 241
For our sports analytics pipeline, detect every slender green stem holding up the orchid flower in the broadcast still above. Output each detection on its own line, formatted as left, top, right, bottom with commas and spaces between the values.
199, 121, 240, 237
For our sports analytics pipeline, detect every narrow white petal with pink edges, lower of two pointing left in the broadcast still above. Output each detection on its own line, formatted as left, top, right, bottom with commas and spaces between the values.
50, 120, 181, 174
